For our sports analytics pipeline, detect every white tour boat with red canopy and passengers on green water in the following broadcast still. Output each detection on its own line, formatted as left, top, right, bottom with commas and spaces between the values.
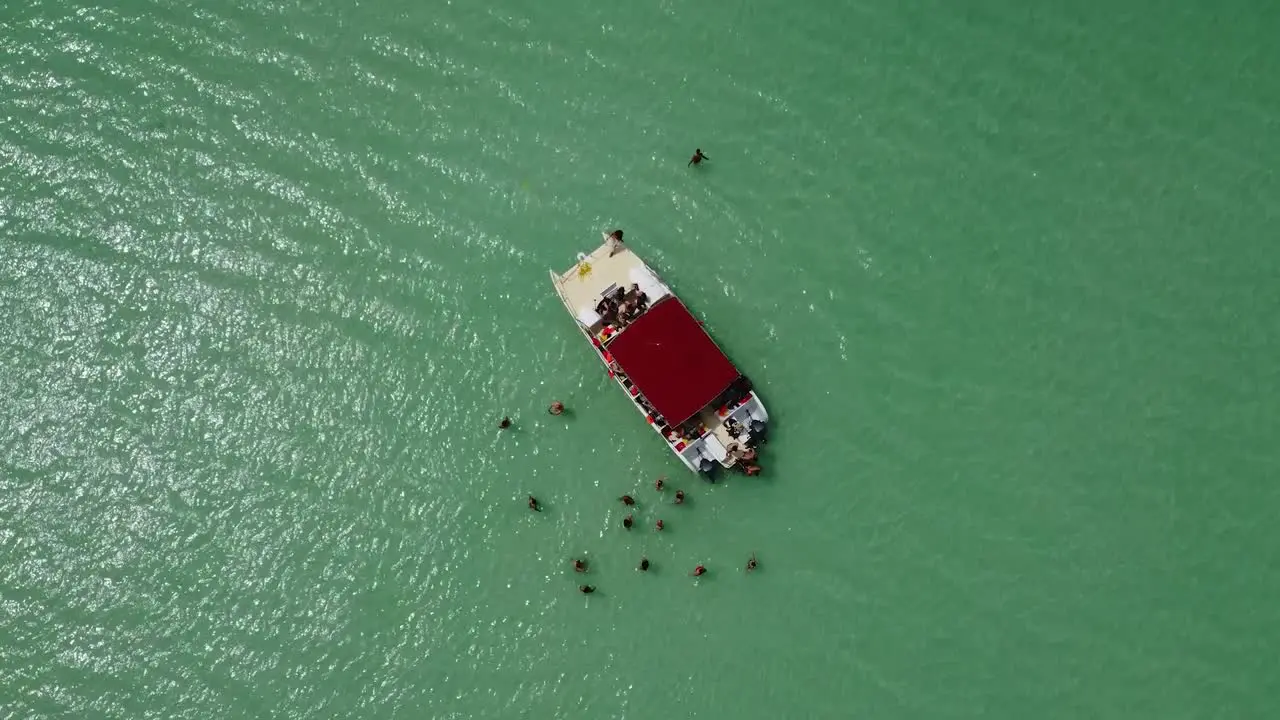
550, 231, 769, 479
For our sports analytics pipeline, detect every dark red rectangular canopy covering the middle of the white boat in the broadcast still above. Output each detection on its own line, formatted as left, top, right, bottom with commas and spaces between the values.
609, 297, 739, 425
